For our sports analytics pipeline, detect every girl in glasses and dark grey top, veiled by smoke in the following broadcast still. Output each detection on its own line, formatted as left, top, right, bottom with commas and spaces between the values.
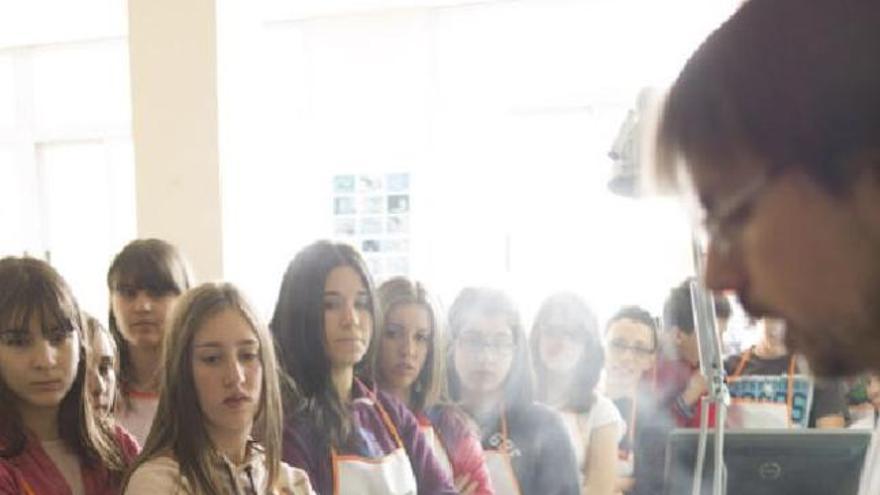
448, 288, 580, 495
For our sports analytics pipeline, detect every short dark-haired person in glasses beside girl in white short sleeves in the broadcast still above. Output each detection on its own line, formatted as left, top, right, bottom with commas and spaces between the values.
604, 306, 662, 491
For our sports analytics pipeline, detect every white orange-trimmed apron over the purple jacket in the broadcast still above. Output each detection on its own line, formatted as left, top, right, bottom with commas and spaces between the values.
330, 394, 418, 495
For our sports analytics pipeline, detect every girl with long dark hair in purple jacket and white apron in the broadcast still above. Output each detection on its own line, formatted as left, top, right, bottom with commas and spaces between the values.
270, 241, 455, 495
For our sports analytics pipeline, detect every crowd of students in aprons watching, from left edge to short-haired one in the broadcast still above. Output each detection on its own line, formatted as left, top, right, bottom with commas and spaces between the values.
0, 239, 656, 495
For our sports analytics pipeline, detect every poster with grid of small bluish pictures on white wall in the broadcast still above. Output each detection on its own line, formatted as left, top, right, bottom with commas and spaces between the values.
333, 173, 410, 282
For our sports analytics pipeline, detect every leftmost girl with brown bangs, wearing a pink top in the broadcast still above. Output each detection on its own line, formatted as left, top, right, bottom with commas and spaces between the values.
0, 257, 138, 495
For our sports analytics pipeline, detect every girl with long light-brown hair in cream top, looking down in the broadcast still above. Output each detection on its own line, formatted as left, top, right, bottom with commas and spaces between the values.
125, 283, 313, 495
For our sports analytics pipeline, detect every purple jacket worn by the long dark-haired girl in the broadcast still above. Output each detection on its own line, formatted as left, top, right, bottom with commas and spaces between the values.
282, 379, 457, 495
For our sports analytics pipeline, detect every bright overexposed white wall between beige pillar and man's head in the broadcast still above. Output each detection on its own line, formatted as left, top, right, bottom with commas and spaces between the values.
219, 0, 735, 324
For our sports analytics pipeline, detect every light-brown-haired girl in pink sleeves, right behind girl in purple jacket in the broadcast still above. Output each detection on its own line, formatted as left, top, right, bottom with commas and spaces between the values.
375, 277, 494, 495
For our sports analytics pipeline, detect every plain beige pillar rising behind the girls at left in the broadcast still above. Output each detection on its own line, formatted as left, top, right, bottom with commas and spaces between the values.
128, 0, 223, 281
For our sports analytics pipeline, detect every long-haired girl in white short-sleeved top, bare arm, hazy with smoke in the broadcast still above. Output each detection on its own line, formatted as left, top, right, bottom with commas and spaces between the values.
530, 292, 623, 495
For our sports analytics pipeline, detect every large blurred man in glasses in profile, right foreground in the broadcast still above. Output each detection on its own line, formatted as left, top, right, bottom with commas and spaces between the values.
656, 0, 880, 494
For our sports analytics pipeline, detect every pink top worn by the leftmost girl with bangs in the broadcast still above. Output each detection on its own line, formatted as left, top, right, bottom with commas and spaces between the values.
0, 426, 140, 495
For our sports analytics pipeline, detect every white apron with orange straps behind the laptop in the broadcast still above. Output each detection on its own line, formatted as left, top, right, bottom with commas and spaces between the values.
727, 349, 813, 428
